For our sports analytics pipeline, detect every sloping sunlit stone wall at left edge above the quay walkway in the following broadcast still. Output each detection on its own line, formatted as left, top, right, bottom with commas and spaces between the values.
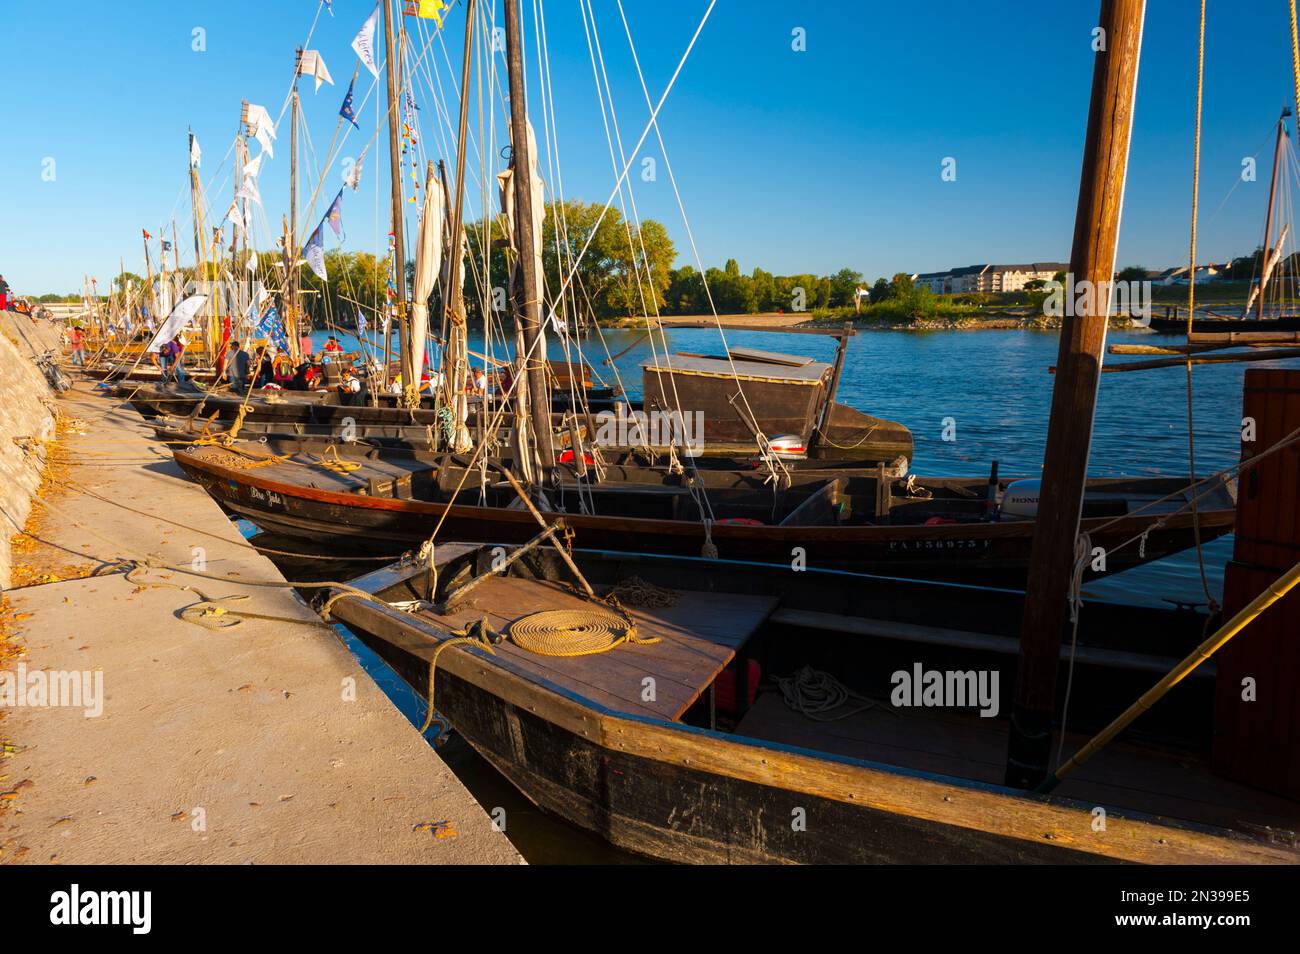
0, 312, 60, 587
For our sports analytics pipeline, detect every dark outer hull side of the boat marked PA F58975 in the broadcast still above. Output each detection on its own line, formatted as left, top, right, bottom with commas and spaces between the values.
176, 448, 1232, 586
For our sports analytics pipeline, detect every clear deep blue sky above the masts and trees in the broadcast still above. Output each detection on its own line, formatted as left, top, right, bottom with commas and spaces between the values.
0, 0, 1292, 292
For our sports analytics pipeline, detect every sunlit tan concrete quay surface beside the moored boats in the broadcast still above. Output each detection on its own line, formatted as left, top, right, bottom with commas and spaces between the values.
0, 383, 521, 864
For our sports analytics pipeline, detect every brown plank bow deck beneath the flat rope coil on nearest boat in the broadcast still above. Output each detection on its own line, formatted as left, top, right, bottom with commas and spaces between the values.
421, 577, 777, 720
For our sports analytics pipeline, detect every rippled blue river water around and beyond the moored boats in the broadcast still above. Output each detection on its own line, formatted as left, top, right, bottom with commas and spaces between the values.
292, 329, 1289, 863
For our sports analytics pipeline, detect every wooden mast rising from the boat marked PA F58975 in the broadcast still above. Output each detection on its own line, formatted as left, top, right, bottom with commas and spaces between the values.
506, 0, 555, 476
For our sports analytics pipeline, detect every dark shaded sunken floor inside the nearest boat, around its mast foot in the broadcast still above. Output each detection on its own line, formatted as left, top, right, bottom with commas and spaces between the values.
736, 693, 1300, 846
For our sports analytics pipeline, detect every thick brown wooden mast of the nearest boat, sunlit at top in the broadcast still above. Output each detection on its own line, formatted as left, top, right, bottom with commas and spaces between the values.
1006, 0, 1145, 788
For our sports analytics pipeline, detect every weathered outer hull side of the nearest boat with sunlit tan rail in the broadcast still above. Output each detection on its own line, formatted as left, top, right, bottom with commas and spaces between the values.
332, 567, 1295, 864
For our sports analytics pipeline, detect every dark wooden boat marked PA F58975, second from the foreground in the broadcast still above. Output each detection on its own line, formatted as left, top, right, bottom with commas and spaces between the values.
173, 438, 1234, 585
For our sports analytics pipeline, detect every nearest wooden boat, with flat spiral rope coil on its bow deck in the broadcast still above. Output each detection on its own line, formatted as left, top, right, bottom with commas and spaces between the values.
319, 545, 1300, 864
